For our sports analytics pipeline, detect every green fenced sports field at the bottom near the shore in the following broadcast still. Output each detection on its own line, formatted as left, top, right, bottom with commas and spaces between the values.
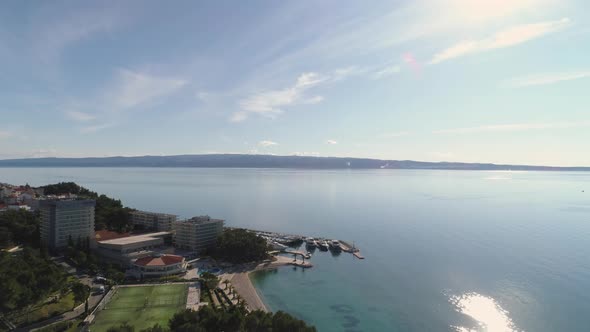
90, 285, 188, 332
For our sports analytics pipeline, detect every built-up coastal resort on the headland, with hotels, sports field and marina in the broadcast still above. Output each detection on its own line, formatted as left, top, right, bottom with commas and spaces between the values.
0, 184, 364, 331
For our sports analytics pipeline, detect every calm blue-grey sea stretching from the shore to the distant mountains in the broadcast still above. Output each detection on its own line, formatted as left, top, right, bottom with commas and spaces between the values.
0, 168, 590, 331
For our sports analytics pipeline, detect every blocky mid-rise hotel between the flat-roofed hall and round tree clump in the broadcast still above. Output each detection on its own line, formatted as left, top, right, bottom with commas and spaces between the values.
172, 216, 223, 252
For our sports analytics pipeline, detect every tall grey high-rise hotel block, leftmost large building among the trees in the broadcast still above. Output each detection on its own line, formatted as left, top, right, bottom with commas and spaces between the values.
39, 200, 96, 249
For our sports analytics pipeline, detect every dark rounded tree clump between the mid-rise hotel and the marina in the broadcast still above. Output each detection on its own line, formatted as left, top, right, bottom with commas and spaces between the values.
213, 228, 268, 263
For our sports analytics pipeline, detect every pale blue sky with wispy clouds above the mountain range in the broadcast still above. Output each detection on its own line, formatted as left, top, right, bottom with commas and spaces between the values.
0, 0, 590, 166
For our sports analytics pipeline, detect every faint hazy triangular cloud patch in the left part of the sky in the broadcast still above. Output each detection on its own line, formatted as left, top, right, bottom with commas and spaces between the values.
106, 69, 187, 110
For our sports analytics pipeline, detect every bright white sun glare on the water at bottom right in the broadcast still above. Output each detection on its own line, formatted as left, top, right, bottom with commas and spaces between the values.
449, 293, 520, 332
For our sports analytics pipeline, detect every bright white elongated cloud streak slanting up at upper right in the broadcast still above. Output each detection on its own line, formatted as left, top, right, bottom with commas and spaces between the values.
429, 18, 571, 64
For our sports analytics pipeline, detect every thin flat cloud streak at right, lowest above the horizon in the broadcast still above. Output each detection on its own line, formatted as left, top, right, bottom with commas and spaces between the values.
432, 121, 590, 134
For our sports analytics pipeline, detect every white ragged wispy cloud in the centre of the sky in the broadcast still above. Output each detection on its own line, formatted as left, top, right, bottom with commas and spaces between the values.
235, 72, 328, 122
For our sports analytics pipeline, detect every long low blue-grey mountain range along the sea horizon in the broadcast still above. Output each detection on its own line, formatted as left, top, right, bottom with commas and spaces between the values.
0, 154, 590, 171
